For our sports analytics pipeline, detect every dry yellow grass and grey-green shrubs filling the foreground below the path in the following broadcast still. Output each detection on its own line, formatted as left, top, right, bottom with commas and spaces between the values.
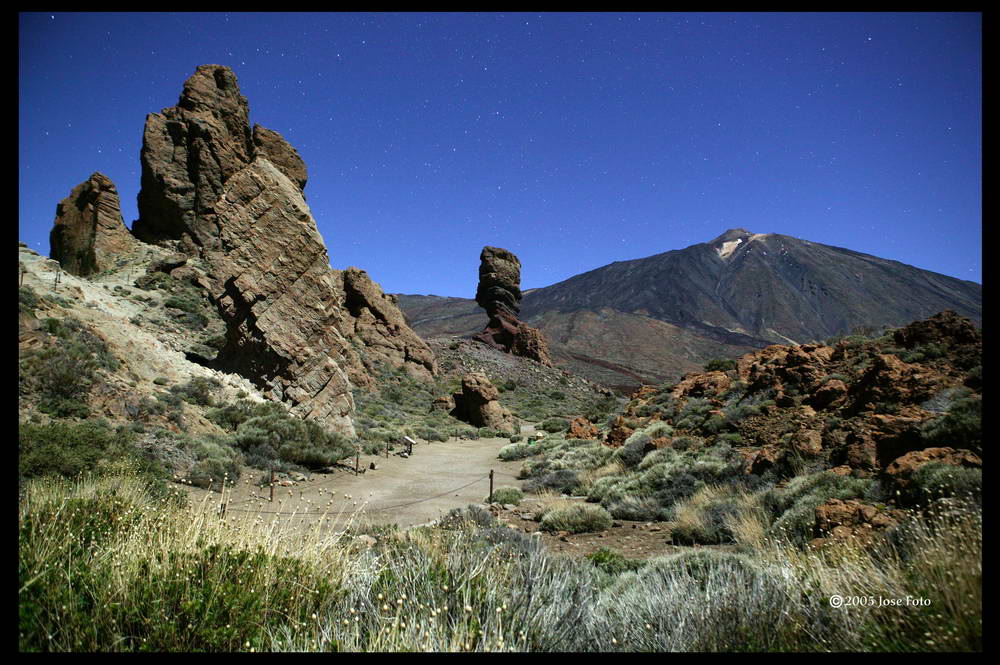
18, 462, 982, 652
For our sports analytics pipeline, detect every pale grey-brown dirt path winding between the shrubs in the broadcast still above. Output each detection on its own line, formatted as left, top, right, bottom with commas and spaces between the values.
188, 438, 521, 529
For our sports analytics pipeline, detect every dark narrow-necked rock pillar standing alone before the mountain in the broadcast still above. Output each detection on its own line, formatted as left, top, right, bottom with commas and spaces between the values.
473, 246, 552, 367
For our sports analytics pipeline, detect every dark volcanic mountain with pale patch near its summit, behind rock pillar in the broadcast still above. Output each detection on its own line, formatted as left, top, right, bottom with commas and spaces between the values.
399, 229, 982, 387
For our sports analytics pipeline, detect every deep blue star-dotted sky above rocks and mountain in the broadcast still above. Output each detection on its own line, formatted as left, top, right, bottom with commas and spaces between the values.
18, 13, 982, 297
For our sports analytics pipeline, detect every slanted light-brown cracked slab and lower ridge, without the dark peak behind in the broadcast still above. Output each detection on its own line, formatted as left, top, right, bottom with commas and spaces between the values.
204, 157, 436, 432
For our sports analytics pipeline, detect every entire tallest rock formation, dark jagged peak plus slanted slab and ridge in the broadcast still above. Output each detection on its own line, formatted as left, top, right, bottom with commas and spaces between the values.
134, 65, 436, 434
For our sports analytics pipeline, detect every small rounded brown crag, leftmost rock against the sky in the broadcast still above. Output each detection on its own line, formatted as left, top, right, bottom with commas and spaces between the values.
49, 173, 139, 277
